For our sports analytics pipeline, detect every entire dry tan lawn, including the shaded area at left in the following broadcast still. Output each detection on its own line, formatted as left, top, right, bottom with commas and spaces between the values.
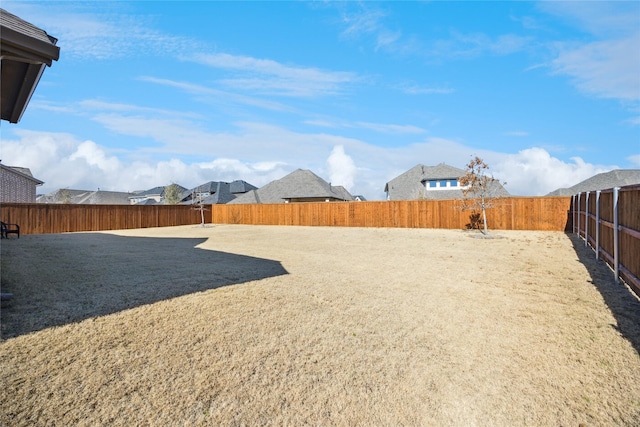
0, 225, 640, 427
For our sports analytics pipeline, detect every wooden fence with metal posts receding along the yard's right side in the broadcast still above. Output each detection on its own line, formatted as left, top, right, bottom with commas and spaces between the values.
571, 185, 640, 296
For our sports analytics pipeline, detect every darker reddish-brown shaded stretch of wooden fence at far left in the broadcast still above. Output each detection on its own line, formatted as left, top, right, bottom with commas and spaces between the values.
0, 203, 201, 234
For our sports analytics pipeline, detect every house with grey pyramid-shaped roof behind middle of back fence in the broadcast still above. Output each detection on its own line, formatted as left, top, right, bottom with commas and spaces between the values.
229, 169, 353, 204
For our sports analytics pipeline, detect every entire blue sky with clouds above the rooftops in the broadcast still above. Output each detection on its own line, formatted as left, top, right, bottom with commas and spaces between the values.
0, 0, 640, 199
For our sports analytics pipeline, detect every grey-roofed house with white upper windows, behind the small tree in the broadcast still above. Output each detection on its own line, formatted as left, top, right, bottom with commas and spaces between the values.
384, 163, 510, 200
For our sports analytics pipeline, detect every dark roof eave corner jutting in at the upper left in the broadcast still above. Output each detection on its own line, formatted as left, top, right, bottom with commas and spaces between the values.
0, 9, 60, 123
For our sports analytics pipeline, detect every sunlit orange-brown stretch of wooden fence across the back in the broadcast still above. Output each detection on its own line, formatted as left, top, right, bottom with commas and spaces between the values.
211, 197, 571, 231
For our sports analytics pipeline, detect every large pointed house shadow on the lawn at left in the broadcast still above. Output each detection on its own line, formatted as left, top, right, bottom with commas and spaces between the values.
0, 233, 288, 339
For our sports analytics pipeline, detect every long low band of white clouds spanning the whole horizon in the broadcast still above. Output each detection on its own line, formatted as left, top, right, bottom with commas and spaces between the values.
0, 129, 620, 200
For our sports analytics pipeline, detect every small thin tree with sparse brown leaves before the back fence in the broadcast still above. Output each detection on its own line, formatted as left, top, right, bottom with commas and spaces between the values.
459, 156, 506, 235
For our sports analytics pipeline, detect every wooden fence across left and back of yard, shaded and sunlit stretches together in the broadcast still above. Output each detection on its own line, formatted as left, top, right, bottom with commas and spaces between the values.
0, 197, 571, 234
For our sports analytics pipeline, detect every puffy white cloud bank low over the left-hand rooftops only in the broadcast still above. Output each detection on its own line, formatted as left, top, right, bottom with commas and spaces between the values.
1, 131, 289, 193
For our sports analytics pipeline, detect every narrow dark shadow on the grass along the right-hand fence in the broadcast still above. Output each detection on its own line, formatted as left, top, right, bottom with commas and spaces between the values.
569, 234, 640, 353
